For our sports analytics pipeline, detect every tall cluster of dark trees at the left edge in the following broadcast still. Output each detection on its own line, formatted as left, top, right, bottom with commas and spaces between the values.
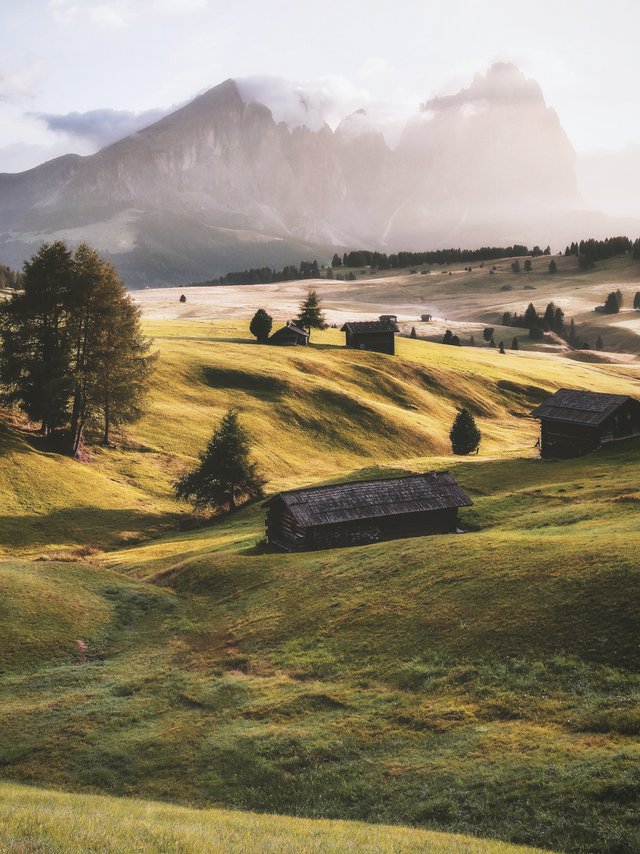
0, 241, 154, 454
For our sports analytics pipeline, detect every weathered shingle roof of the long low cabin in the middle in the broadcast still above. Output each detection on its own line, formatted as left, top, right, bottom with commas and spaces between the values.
265, 471, 473, 527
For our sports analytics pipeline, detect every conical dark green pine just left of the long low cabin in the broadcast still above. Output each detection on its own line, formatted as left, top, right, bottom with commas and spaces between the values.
174, 409, 266, 511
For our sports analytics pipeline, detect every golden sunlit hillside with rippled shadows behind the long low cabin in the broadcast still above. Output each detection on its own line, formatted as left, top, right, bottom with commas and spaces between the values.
5, 321, 640, 557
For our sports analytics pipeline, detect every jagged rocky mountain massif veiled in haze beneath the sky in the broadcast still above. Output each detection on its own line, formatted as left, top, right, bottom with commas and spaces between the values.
0, 63, 622, 286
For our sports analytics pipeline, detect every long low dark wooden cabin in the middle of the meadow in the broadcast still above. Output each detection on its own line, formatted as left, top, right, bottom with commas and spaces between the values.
264, 472, 473, 552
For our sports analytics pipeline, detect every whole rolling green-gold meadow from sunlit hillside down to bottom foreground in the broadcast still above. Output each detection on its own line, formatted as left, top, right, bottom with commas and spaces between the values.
0, 310, 640, 852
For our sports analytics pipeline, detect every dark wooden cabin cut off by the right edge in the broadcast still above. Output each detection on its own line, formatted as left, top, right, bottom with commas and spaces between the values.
531, 388, 640, 459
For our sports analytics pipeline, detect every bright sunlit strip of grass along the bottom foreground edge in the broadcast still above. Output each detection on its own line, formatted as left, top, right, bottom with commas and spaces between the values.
0, 784, 544, 854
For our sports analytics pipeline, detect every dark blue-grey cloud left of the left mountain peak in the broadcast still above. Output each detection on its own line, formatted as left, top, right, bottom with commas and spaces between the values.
34, 107, 170, 148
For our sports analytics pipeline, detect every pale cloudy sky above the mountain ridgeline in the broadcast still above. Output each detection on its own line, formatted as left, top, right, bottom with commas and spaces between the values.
0, 0, 640, 178
